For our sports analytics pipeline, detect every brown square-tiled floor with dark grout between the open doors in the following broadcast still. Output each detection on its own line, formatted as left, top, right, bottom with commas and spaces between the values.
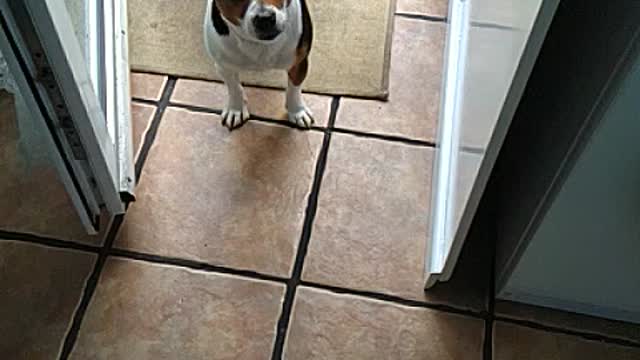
0, 0, 640, 360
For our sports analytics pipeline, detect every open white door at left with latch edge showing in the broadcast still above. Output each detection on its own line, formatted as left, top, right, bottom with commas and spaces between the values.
0, 0, 135, 233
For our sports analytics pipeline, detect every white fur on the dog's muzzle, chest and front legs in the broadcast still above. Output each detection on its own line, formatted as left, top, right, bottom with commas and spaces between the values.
204, 0, 313, 129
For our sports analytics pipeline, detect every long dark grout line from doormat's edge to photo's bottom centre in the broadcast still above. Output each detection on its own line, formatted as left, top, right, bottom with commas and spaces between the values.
271, 97, 340, 360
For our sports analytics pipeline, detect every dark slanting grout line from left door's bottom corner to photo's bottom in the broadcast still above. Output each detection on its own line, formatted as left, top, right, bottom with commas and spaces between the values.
60, 215, 124, 360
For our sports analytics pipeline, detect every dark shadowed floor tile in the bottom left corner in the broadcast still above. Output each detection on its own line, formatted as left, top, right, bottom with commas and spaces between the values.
0, 240, 95, 360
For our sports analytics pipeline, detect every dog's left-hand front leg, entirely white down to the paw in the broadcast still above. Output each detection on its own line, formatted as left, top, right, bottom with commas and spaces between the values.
218, 66, 249, 130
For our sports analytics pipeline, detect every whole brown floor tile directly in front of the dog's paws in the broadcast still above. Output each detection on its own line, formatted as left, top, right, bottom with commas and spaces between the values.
115, 108, 323, 276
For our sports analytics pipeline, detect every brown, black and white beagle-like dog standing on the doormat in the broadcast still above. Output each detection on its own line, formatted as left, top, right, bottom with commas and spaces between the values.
204, 0, 313, 130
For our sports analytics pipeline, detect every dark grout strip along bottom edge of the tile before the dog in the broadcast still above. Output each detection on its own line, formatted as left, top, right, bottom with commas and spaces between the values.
109, 248, 288, 283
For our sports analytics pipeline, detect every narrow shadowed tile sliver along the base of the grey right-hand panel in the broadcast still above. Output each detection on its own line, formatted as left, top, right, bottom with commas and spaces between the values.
495, 301, 640, 344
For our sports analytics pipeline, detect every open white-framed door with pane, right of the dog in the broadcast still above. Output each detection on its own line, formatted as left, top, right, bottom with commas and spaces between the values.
426, 0, 559, 288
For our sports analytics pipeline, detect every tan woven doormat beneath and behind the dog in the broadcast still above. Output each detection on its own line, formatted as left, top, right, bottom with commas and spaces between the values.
128, 0, 395, 98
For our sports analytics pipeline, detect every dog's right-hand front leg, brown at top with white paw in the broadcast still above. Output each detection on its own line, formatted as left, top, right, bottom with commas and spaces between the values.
287, 58, 313, 128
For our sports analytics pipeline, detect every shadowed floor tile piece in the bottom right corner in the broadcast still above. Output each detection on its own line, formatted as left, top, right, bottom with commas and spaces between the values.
493, 322, 640, 360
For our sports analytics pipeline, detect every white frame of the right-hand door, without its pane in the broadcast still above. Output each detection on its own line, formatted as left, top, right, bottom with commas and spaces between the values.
425, 0, 559, 289
